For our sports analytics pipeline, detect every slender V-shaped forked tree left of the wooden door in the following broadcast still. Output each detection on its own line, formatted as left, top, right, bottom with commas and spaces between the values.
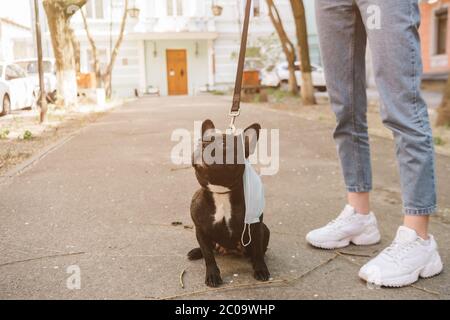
81, 0, 128, 99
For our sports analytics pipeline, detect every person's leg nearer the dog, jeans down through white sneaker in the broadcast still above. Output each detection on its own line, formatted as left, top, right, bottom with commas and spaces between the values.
306, 0, 380, 249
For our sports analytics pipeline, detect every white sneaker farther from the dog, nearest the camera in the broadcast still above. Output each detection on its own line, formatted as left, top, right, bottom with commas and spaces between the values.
359, 226, 443, 287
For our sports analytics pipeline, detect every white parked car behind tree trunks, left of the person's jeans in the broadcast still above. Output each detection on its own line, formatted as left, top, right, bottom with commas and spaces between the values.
262, 61, 327, 91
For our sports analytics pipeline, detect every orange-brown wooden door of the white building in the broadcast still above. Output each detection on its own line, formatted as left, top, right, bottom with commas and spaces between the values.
166, 50, 188, 96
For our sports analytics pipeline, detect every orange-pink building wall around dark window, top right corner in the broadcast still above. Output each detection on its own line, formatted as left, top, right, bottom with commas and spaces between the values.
419, 0, 450, 77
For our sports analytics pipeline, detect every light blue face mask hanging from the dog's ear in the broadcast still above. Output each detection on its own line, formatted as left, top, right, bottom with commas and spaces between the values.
241, 135, 265, 247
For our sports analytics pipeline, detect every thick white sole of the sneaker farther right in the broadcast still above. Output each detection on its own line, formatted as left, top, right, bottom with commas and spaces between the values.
359, 253, 444, 288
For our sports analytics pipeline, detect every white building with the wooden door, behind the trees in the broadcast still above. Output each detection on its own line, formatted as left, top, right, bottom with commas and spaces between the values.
68, 0, 320, 96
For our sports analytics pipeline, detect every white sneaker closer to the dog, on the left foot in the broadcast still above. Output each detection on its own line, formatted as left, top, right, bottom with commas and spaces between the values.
306, 205, 380, 249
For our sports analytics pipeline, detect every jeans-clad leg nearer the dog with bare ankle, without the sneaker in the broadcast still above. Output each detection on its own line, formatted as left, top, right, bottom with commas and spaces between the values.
316, 0, 372, 214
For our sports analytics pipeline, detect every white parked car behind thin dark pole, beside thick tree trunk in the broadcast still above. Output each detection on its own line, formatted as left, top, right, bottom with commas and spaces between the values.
15, 58, 57, 102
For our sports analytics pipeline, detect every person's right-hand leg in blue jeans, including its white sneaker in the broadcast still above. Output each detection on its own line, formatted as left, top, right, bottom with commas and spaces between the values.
355, 0, 443, 287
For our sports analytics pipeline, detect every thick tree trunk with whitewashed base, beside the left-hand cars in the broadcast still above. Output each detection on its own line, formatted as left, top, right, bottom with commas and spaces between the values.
43, 0, 87, 106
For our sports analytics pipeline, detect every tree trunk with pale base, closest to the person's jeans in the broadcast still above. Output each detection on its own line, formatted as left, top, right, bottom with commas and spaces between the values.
290, 0, 316, 105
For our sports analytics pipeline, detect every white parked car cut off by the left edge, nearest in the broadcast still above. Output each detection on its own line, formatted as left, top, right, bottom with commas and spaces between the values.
0, 62, 36, 115
